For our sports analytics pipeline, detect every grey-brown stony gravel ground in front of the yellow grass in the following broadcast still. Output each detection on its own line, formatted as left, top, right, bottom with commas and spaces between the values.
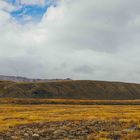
0, 120, 140, 140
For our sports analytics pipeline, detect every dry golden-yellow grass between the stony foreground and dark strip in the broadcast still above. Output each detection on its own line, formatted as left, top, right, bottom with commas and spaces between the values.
0, 104, 140, 131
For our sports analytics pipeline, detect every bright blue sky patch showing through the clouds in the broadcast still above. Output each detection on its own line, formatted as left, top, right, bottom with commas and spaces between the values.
7, 0, 57, 24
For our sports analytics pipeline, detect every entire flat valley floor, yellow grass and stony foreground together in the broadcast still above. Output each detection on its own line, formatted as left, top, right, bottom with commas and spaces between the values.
0, 104, 140, 140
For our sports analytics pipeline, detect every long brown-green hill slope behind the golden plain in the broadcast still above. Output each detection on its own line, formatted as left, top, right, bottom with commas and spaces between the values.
0, 80, 140, 100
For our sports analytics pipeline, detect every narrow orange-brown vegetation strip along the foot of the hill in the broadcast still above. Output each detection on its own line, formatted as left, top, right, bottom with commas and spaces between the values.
0, 98, 140, 105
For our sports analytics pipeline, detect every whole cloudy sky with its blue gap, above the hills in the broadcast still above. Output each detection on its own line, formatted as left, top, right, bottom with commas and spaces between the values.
0, 0, 140, 83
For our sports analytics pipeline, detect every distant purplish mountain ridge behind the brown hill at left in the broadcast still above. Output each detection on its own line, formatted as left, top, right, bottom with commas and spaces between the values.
0, 75, 70, 82
